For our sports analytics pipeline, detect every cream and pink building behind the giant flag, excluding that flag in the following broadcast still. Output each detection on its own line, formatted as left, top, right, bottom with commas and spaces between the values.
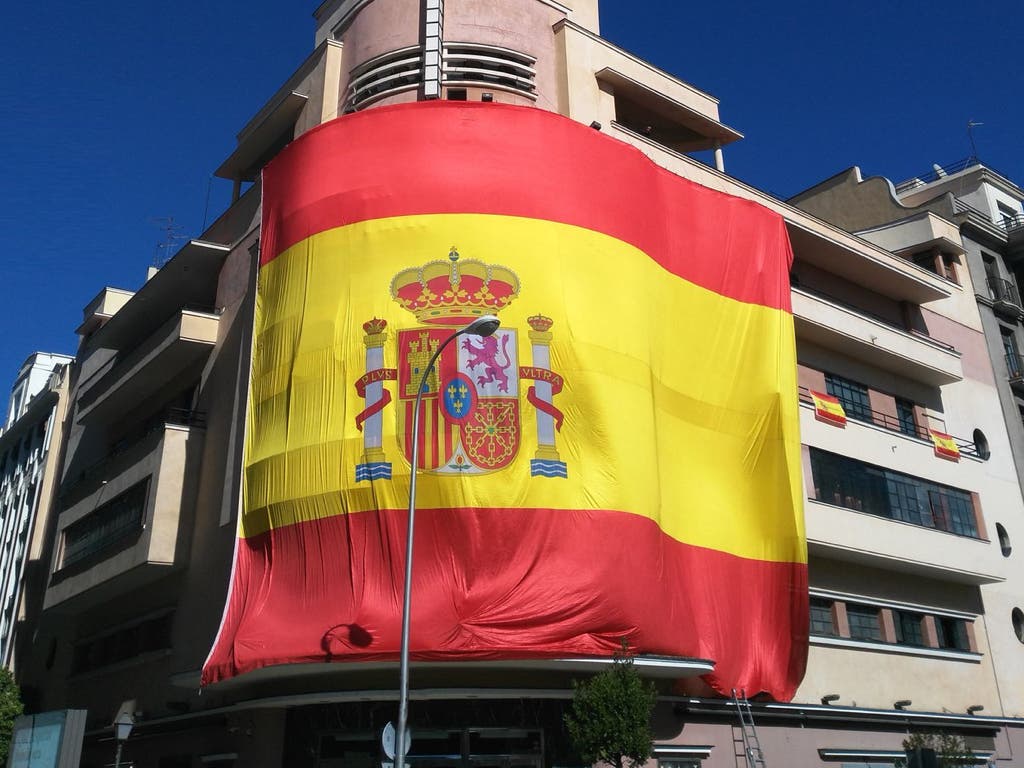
14, 0, 1024, 768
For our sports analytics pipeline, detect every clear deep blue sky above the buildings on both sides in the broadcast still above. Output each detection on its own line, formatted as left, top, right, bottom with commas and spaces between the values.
0, 0, 1024, 385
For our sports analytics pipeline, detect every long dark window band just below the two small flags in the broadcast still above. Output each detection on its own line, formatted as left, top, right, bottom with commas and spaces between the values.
810, 447, 978, 538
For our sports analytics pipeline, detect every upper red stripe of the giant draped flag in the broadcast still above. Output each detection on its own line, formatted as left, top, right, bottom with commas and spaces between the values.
260, 101, 792, 311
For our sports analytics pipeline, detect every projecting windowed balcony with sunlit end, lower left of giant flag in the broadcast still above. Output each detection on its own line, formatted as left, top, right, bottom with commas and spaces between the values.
44, 412, 203, 612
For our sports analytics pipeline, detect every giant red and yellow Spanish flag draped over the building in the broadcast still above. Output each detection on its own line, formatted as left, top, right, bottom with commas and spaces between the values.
203, 102, 808, 699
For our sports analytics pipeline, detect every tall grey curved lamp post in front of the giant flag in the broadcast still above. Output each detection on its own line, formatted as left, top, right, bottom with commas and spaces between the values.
394, 314, 501, 768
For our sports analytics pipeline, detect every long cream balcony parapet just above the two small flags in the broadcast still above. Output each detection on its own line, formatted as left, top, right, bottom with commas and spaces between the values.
793, 288, 964, 386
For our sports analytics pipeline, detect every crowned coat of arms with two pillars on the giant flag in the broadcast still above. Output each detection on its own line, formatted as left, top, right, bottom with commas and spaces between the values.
355, 248, 566, 481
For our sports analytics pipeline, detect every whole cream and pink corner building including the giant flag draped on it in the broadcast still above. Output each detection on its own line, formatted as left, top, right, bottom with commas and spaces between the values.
16, 0, 1024, 768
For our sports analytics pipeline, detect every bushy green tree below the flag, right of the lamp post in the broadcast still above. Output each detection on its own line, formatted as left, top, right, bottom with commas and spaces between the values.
565, 640, 657, 768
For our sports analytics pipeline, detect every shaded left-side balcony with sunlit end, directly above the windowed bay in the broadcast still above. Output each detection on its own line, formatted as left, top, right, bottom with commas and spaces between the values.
78, 309, 220, 422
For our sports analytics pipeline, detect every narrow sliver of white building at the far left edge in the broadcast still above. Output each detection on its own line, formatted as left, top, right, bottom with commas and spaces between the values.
0, 352, 72, 669
